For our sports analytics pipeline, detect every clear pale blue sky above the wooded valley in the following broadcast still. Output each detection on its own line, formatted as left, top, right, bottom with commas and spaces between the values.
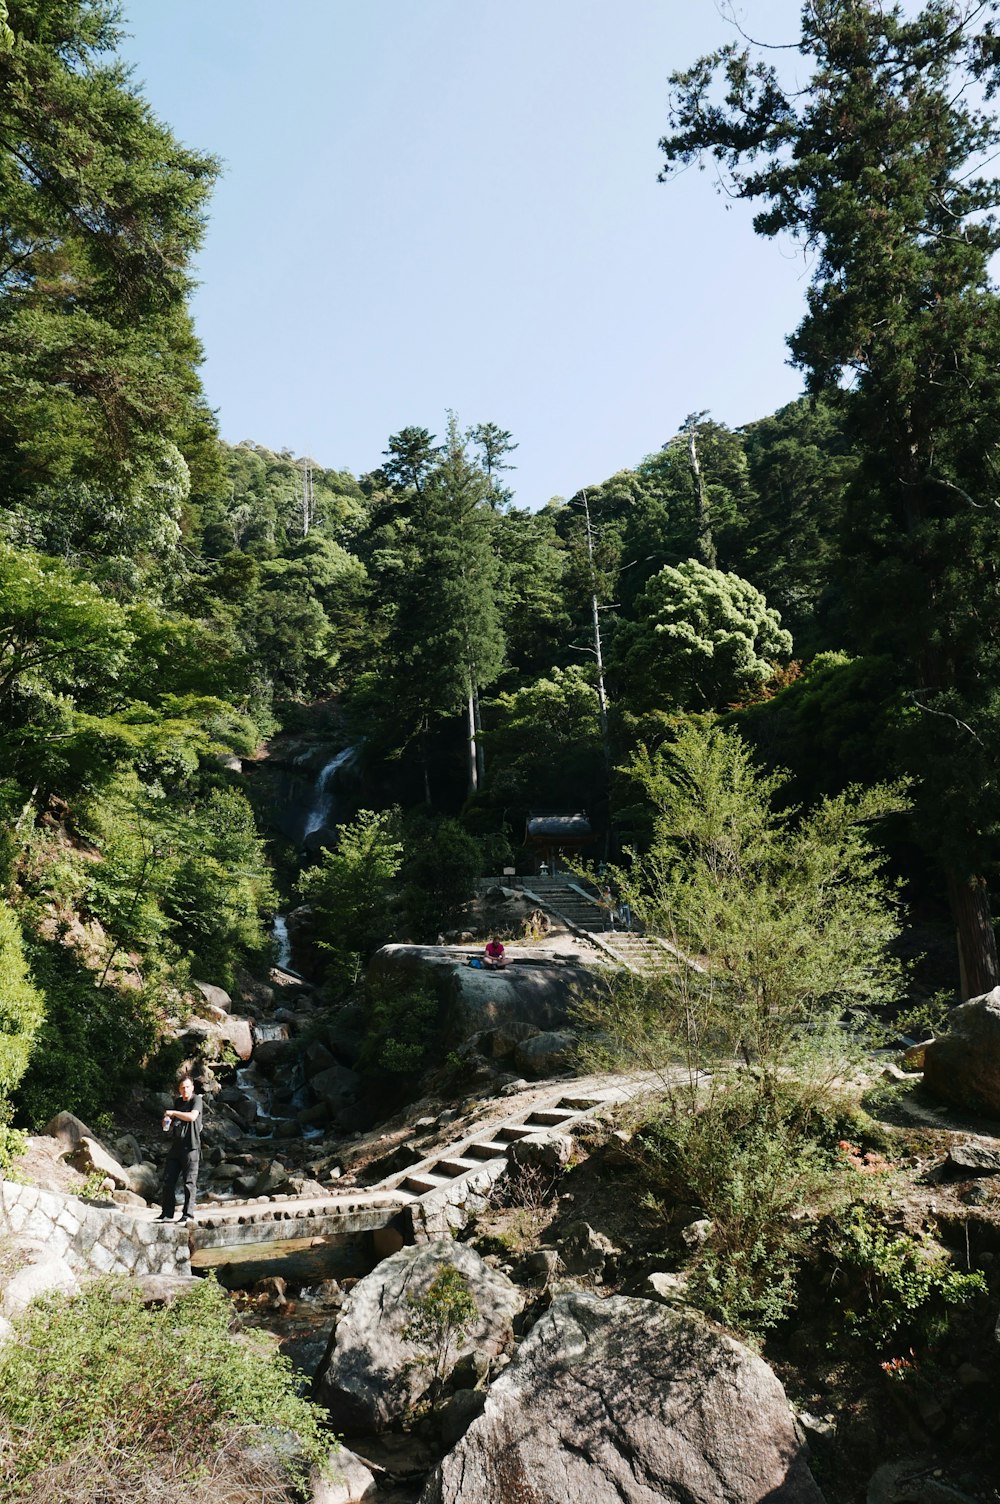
122, 0, 808, 507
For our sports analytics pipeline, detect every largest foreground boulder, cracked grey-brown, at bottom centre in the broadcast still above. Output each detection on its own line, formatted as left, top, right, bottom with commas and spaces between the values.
421, 1295, 823, 1504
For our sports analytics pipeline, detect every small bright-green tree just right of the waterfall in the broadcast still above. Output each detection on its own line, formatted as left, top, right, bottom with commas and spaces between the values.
298, 809, 403, 987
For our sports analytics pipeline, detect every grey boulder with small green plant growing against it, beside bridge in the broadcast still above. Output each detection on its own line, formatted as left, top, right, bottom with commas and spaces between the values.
314, 1239, 522, 1433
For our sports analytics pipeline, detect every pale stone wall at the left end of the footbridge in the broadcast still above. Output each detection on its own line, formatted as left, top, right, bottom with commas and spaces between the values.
0, 1181, 191, 1275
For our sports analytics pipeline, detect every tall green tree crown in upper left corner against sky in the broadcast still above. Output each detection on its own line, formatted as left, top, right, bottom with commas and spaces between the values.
0, 0, 217, 510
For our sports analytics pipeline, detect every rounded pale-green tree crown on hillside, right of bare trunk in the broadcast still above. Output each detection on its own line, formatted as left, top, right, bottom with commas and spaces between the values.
617, 559, 791, 710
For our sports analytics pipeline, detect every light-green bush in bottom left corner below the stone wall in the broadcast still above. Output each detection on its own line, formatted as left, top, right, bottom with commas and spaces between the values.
0, 1280, 331, 1499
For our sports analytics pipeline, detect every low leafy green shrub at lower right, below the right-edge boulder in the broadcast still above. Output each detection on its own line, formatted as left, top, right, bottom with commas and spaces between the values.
827, 1202, 986, 1349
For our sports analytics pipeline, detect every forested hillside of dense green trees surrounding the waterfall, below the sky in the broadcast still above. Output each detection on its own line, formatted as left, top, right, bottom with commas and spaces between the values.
0, 0, 1000, 1161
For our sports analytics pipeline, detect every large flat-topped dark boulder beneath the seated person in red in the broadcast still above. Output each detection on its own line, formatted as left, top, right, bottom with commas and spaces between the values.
365, 945, 597, 1042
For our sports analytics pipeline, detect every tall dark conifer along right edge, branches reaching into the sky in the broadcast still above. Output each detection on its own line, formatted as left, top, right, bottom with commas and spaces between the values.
662, 0, 1000, 991
